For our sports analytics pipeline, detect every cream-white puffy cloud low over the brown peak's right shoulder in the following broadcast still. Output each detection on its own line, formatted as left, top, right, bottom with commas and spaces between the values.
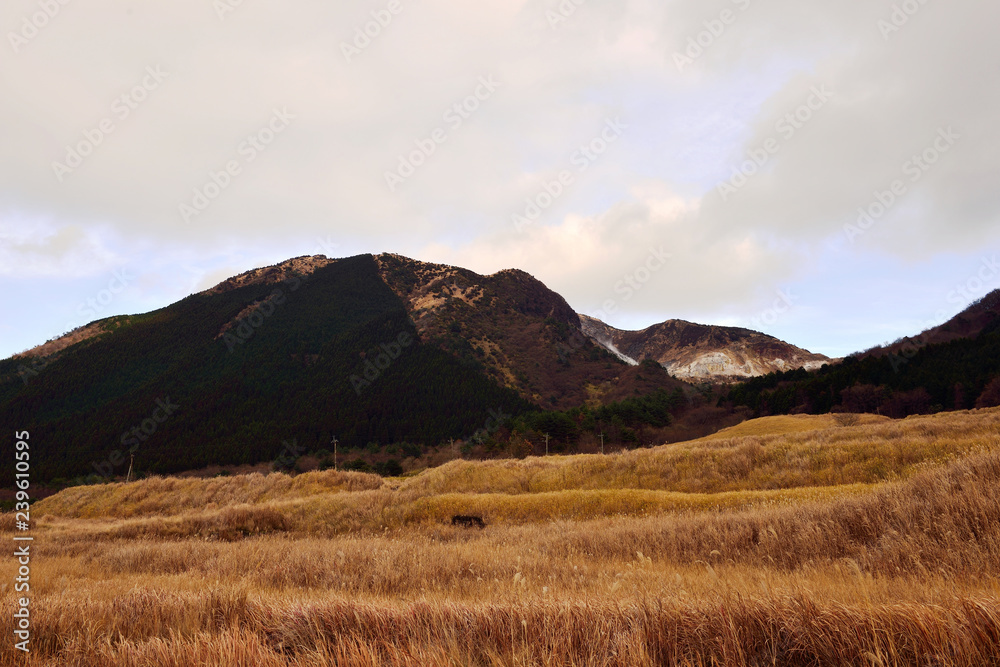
417, 186, 793, 319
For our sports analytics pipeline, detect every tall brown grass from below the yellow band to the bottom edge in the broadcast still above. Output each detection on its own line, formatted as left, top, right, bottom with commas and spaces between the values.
0, 452, 1000, 667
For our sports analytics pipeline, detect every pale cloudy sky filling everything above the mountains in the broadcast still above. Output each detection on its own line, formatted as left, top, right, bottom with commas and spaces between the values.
0, 0, 1000, 358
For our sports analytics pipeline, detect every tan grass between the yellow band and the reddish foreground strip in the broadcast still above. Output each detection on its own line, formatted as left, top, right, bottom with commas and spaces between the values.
21, 452, 1000, 595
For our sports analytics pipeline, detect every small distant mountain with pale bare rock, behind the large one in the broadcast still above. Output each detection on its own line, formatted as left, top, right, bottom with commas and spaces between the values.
580, 315, 830, 382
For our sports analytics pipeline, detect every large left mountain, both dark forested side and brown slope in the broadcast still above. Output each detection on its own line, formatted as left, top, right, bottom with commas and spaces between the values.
0, 255, 682, 485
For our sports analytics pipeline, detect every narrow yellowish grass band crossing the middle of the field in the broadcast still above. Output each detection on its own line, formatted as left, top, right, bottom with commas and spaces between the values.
37, 485, 872, 541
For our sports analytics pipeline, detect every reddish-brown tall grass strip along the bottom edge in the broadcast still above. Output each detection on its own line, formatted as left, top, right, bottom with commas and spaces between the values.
0, 591, 1000, 667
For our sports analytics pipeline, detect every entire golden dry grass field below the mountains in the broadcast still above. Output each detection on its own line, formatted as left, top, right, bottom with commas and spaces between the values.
0, 409, 1000, 667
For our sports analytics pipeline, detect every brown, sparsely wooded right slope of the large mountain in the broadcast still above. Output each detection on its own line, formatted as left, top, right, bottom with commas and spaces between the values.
375, 254, 681, 409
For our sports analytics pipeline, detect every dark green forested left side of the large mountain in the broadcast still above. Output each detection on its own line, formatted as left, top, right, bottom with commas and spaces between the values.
0, 255, 534, 482
